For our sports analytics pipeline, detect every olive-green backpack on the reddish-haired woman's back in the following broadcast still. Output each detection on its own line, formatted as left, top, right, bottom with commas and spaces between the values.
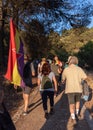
41, 75, 53, 89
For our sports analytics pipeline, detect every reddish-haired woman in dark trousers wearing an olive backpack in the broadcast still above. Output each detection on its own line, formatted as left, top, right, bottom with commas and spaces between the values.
38, 63, 57, 119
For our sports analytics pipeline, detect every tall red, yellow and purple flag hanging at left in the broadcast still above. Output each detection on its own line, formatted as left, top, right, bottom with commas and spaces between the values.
4, 20, 24, 86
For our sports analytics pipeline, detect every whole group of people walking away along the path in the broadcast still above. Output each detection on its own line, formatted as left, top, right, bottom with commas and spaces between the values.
20, 56, 87, 123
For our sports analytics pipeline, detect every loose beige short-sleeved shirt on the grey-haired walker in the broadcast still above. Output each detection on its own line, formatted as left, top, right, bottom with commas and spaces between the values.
62, 64, 86, 93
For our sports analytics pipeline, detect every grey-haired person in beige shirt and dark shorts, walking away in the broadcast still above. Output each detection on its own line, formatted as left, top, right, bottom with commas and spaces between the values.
62, 56, 87, 124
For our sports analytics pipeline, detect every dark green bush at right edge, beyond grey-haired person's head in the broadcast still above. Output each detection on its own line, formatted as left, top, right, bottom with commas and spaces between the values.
78, 41, 93, 67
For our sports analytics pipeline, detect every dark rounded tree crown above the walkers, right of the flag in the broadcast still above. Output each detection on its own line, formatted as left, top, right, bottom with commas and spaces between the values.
22, 20, 51, 58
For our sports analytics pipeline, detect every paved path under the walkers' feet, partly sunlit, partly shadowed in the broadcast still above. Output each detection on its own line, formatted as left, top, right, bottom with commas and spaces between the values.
15, 85, 90, 130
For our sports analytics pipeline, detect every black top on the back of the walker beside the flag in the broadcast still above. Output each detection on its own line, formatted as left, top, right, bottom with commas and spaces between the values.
23, 62, 32, 87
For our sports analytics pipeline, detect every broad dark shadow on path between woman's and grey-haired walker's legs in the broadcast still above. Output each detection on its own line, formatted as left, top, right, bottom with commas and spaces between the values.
40, 93, 90, 130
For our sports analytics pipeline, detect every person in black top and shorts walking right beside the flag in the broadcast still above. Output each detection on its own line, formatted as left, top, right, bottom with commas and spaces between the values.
22, 58, 35, 115
